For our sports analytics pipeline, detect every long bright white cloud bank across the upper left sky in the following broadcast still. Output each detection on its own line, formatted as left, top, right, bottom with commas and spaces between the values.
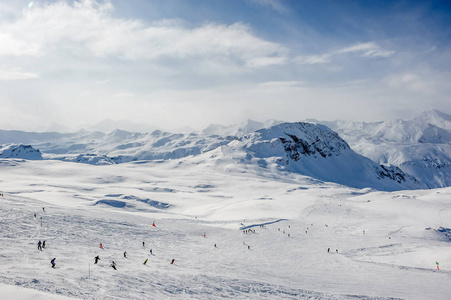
0, 0, 287, 67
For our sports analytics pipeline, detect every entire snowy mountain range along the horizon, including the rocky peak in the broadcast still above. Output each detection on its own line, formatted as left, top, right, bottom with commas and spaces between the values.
0, 110, 451, 190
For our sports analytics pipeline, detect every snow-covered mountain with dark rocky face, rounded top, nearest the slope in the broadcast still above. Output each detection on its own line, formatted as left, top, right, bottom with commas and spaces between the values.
215, 123, 427, 190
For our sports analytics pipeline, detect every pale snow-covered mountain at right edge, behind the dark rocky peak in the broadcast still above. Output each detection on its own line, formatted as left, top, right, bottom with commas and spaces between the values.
316, 110, 451, 188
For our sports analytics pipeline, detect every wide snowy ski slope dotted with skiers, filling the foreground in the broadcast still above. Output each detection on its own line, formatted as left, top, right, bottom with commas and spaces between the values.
0, 157, 451, 299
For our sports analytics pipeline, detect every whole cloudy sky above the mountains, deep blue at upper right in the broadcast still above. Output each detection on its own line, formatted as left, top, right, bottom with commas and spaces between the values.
0, 0, 451, 131
